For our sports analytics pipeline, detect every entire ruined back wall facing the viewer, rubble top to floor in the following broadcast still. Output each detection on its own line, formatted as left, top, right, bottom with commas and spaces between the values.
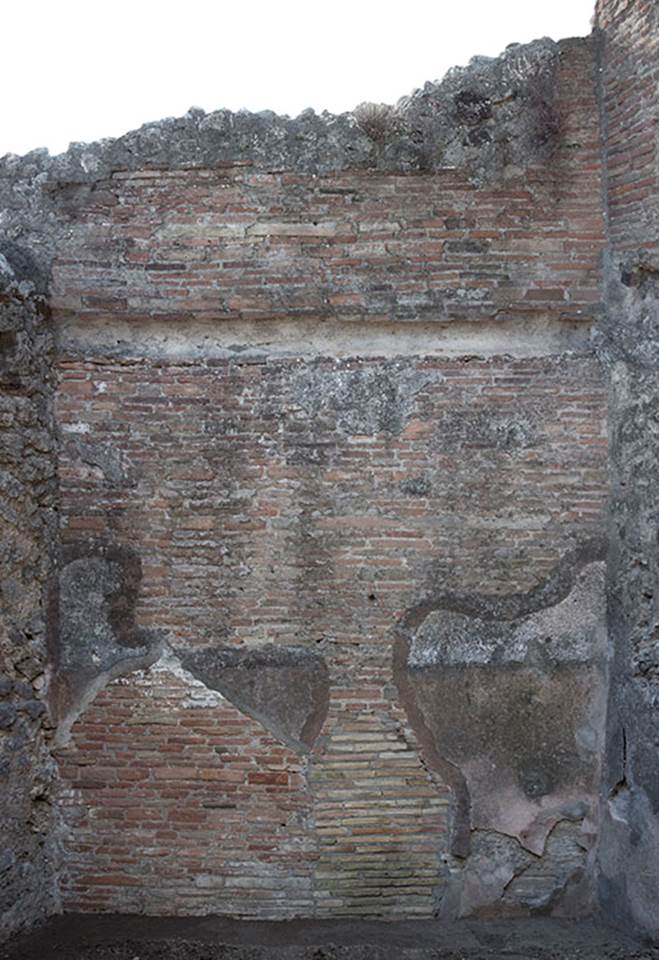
0, 31, 608, 918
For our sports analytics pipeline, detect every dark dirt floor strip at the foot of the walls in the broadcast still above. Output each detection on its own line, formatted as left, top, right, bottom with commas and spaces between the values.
0, 915, 659, 960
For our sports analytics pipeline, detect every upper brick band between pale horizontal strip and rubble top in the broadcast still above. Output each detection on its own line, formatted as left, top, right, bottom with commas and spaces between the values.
52, 41, 602, 338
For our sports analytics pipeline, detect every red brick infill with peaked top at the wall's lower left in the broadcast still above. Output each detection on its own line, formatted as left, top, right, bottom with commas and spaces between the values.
58, 664, 316, 918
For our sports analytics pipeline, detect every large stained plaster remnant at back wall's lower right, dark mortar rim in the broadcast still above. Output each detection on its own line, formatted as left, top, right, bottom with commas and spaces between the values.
394, 541, 608, 915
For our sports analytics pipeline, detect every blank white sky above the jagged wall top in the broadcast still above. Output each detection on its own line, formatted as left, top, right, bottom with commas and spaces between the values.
0, 0, 595, 156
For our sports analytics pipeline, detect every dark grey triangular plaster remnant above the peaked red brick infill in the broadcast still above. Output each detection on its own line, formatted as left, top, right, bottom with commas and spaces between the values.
177, 644, 329, 752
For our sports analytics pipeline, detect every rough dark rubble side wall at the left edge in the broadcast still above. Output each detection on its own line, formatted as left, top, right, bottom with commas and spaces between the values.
0, 256, 58, 940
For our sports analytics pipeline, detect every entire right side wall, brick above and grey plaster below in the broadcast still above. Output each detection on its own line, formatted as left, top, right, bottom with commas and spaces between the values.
598, 0, 659, 935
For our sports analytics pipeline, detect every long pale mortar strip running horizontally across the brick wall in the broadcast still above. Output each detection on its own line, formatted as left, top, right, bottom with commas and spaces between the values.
57, 313, 591, 360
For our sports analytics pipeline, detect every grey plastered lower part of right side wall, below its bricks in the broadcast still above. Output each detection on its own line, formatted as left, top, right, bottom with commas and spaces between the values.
597, 362, 659, 937
